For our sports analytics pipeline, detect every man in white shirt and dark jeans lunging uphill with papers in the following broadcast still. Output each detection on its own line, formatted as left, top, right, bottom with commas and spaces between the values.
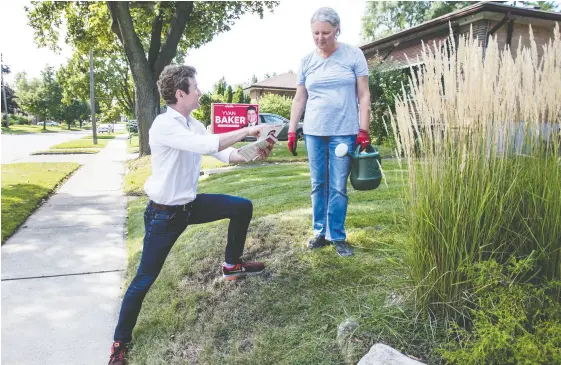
109, 65, 271, 365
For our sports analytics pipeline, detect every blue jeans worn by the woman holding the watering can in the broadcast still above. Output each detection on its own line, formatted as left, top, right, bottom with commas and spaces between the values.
305, 135, 356, 241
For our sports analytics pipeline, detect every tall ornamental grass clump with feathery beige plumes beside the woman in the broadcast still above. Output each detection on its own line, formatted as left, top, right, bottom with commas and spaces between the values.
389, 24, 561, 319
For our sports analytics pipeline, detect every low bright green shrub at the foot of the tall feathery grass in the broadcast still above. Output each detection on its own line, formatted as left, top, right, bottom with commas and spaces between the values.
440, 257, 561, 365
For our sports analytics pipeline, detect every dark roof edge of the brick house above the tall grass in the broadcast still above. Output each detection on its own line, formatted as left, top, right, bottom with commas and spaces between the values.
360, 2, 561, 53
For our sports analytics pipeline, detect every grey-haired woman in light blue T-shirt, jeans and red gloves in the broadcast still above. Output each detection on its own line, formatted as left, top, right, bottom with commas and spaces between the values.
288, 8, 370, 256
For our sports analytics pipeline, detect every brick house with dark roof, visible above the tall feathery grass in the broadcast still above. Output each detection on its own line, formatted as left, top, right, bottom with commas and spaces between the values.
360, 2, 561, 67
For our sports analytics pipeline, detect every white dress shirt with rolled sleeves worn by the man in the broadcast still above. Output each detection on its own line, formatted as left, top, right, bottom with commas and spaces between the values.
144, 106, 235, 205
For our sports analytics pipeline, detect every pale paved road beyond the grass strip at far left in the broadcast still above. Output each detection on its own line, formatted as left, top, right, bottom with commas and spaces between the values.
2, 131, 87, 163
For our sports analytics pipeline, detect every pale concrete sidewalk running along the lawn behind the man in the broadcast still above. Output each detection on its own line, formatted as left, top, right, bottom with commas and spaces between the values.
2, 136, 127, 365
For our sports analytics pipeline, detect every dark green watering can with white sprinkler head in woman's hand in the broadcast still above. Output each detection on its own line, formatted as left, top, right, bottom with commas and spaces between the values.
335, 143, 382, 190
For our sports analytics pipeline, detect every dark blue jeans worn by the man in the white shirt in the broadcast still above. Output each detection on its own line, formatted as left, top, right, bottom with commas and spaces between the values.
114, 194, 253, 343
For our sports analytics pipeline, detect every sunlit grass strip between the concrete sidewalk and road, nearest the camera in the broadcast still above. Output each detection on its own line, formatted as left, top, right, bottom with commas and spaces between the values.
2, 163, 80, 243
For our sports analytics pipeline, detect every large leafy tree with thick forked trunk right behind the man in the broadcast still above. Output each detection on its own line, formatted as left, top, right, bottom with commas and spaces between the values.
26, 1, 278, 155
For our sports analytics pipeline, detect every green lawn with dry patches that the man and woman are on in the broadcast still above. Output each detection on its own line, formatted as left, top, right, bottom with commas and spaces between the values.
120, 161, 440, 365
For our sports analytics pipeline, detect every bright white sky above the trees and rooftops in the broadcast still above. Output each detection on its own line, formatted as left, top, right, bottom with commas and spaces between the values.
0, 0, 366, 92
